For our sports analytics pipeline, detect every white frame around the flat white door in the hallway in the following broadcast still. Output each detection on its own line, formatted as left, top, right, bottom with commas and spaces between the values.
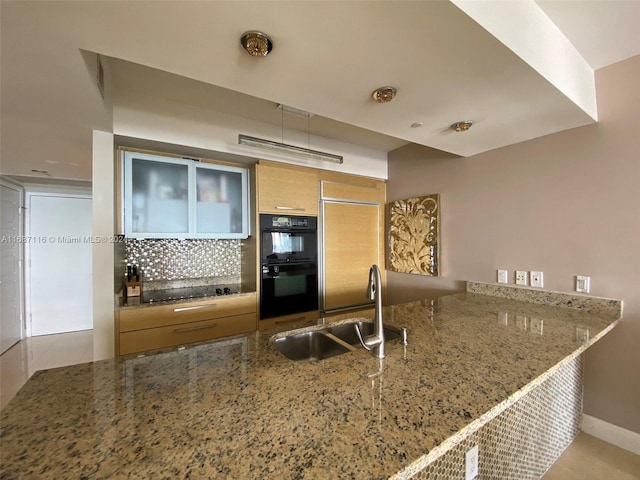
23, 185, 93, 337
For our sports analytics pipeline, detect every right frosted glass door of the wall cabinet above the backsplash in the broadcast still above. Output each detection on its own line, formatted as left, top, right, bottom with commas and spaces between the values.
196, 164, 247, 237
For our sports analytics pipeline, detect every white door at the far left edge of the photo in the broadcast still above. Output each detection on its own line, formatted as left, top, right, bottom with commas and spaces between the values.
0, 185, 23, 353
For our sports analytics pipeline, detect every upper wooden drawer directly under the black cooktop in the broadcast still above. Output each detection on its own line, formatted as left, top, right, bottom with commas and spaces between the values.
120, 294, 256, 332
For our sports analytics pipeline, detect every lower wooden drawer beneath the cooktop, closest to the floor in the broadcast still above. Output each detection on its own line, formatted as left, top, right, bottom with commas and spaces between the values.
120, 313, 256, 355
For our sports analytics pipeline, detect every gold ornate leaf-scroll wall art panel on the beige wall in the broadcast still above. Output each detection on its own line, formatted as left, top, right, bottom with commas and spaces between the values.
389, 194, 440, 276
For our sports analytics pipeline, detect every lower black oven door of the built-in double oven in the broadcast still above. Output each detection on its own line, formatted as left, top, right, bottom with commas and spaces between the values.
260, 263, 318, 319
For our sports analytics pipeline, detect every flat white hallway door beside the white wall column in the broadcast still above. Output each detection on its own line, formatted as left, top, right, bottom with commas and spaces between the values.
27, 194, 93, 335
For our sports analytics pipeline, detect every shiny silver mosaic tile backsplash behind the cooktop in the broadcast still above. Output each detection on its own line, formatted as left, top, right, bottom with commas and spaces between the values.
122, 238, 241, 282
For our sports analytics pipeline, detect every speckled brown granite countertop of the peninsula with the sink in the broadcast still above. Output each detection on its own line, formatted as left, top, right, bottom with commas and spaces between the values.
0, 284, 620, 479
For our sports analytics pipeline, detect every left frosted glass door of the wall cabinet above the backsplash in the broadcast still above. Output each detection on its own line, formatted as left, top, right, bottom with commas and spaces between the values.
125, 155, 190, 237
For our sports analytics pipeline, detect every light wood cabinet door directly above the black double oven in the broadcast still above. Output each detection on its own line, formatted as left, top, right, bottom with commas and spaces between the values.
257, 162, 319, 215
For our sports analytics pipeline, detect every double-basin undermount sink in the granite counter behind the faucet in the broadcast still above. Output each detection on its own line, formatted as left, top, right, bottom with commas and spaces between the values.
274, 321, 400, 361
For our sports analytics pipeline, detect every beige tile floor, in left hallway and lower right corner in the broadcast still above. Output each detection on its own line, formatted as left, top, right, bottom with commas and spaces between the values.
0, 330, 640, 480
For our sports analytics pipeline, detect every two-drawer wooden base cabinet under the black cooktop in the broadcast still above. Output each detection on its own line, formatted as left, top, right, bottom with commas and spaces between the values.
117, 294, 256, 355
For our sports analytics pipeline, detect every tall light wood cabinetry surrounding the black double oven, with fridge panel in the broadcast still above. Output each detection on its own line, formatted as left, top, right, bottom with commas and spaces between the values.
256, 161, 386, 322
